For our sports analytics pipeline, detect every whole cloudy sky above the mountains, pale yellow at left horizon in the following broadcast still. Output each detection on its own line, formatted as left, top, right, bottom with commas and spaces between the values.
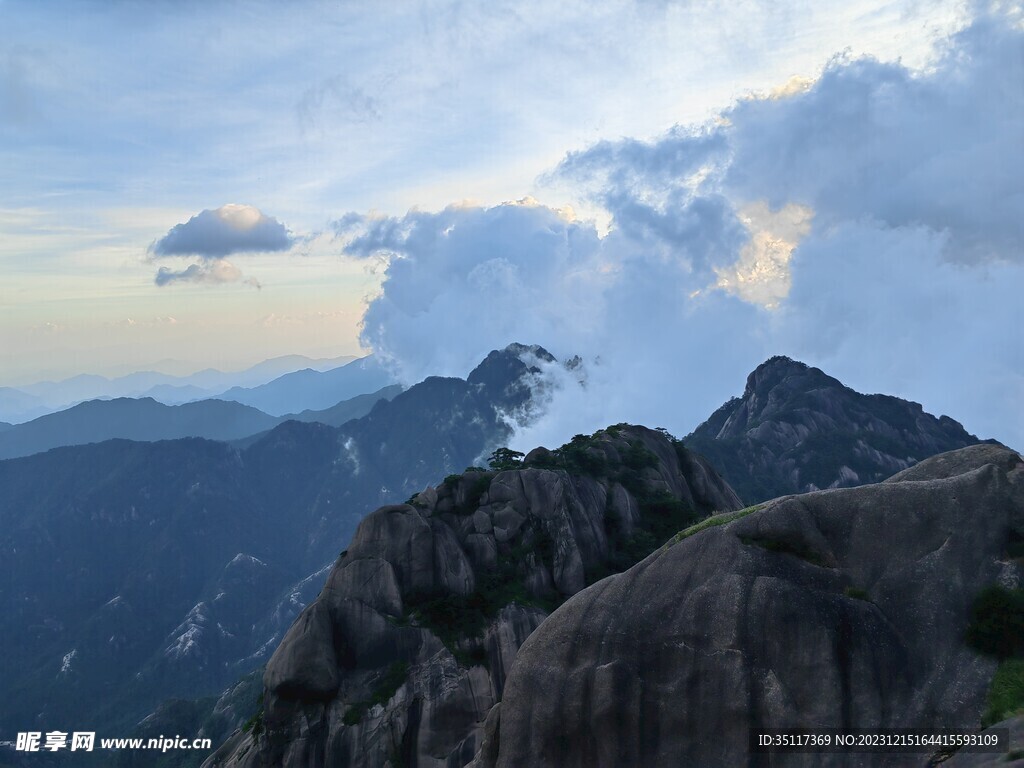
0, 0, 1024, 447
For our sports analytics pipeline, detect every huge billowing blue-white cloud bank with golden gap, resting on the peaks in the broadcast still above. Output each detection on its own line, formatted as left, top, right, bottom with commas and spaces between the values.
339, 13, 1024, 447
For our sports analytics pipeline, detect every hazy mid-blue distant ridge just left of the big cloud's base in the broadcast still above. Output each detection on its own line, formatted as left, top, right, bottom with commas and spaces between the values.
217, 356, 394, 416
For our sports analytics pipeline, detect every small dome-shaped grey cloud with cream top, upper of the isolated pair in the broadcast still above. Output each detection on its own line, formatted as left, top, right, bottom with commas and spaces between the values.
150, 204, 295, 260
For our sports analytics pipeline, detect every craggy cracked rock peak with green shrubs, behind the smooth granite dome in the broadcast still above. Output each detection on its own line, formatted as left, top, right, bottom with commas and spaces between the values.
208, 425, 739, 768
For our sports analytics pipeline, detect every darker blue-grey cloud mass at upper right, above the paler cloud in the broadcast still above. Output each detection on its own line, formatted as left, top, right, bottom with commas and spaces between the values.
722, 14, 1024, 262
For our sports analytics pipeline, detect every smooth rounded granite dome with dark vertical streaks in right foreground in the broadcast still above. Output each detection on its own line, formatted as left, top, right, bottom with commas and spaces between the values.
485, 444, 1024, 768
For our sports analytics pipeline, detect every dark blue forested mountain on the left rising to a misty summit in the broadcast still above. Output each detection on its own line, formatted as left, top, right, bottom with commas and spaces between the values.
0, 347, 550, 753
